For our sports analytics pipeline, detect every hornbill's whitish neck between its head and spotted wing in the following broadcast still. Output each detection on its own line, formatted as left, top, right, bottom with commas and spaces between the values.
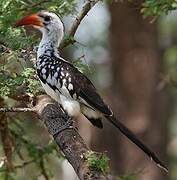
37, 31, 62, 58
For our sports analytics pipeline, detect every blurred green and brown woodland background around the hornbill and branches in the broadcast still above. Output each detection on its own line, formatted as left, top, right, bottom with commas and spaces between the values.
0, 0, 177, 180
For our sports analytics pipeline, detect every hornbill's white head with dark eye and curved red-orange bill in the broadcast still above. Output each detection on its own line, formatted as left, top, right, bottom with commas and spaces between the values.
16, 11, 64, 50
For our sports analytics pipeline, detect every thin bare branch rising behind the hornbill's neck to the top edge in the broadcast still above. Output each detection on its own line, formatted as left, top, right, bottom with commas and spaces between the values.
60, 0, 99, 49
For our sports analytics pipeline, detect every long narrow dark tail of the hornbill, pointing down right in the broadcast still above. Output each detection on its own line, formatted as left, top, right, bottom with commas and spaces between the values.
105, 116, 168, 172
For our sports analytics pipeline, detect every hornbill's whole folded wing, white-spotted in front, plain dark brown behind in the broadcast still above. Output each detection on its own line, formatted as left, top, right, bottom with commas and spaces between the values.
37, 56, 112, 115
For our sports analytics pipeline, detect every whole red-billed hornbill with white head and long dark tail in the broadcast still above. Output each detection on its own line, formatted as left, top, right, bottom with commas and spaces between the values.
15, 11, 168, 171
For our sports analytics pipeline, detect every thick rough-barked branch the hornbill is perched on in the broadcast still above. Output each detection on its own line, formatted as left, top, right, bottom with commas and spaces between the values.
35, 95, 110, 180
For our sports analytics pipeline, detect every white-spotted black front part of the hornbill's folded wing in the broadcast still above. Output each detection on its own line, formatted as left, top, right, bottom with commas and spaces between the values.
36, 55, 77, 100
